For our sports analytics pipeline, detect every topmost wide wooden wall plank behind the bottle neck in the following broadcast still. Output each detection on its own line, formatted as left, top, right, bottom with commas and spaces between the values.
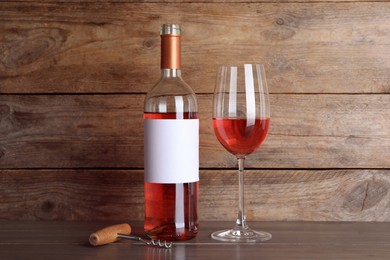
0, 2, 390, 93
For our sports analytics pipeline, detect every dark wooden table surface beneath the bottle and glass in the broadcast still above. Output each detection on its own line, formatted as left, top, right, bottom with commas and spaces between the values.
0, 221, 390, 260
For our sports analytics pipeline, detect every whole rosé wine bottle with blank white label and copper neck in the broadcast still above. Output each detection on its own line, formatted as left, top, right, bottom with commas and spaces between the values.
144, 24, 199, 241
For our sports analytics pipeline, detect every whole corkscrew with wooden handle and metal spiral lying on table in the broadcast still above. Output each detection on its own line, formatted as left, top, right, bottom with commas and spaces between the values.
89, 224, 172, 248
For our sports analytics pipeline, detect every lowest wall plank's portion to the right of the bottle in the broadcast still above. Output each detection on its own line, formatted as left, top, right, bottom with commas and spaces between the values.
200, 170, 390, 221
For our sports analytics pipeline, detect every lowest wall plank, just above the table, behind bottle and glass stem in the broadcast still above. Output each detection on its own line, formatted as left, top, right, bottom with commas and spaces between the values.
0, 170, 390, 223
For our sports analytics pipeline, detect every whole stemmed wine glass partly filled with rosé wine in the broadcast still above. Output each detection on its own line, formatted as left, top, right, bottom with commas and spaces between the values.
211, 64, 272, 242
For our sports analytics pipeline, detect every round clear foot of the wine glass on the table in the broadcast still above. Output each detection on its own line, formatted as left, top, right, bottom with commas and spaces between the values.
211, 228, 272, 243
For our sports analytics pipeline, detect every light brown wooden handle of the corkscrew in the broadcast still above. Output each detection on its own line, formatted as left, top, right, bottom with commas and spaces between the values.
89, 223, 131, 246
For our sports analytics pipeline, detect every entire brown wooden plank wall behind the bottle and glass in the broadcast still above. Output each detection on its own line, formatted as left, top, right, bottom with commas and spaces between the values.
0, 0, 390, 221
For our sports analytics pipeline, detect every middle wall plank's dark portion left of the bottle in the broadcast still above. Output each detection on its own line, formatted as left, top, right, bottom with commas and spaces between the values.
0, 95, 143, 168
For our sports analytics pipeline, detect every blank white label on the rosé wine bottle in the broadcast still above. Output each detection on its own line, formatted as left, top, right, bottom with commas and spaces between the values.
144, 119, 199, 183
